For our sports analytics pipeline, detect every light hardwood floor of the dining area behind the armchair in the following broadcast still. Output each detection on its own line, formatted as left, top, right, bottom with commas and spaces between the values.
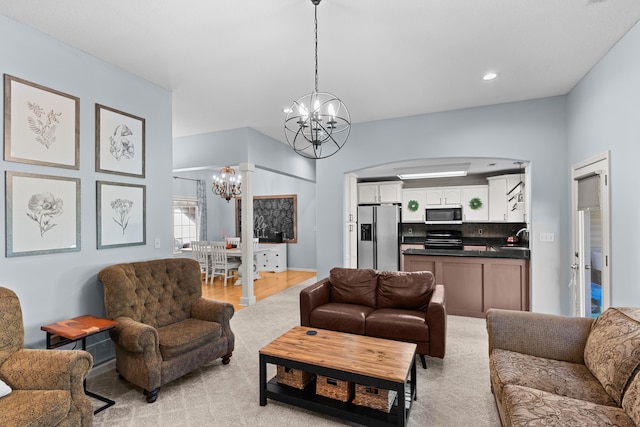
202, 270, 316, 310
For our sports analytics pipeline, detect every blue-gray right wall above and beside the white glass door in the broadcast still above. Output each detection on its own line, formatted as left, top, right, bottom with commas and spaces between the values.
567, 24, 640, 307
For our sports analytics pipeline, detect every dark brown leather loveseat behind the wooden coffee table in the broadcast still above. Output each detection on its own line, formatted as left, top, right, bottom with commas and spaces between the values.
300, 268, 447, 368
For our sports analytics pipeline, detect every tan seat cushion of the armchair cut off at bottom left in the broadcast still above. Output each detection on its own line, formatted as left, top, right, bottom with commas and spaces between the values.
0, 390, 71, 427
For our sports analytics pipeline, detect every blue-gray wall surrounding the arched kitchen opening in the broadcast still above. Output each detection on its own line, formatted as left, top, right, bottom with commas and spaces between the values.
316, 97, 570, 313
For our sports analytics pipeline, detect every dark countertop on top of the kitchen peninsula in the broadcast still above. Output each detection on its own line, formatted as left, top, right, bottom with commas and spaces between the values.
401, 236, 531, 259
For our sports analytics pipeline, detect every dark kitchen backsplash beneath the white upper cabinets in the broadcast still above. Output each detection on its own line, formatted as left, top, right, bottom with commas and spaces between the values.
401, 222, 529, 240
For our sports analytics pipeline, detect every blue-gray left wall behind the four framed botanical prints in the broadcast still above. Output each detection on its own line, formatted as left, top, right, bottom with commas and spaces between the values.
0, 15, 173, 347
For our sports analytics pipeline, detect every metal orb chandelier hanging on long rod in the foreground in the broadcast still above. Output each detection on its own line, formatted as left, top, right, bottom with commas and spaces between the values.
284, 0, 351, 159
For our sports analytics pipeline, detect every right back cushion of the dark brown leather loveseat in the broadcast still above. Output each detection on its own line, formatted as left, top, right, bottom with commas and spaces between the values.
377, 271, 435, 311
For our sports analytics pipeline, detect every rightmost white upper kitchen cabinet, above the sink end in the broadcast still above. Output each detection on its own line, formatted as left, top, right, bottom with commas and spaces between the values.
487, 174, 526, 222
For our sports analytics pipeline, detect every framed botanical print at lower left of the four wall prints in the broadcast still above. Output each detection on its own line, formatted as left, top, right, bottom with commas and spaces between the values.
5, 171, 80, 257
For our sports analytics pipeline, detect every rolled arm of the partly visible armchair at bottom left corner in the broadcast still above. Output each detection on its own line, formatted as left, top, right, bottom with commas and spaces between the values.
0, 349, 93, 399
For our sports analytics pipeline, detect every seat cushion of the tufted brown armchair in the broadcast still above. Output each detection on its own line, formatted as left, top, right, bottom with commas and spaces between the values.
158, 318, 222, 360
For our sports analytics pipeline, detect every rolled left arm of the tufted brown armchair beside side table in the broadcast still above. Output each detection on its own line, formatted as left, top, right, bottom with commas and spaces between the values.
109, 317, 160, 358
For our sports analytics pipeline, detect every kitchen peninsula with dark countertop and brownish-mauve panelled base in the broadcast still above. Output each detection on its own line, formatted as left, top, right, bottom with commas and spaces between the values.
402, 240, 530, 317
